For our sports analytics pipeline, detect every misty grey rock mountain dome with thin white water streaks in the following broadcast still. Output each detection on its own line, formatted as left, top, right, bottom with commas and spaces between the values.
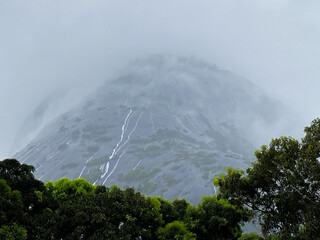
14, 55, 280, 203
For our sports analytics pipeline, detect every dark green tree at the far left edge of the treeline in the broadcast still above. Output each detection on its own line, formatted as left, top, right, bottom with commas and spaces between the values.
0, 159, 52, 239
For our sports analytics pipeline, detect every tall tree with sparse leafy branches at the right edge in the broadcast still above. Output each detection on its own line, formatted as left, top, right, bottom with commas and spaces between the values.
214, 119, 320, 239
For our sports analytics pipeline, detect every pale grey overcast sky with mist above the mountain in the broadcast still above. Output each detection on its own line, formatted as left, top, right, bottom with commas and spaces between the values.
0, 0, 320, 159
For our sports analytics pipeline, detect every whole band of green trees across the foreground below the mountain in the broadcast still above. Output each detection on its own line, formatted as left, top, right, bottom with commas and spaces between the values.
0, 119, 320, 240
